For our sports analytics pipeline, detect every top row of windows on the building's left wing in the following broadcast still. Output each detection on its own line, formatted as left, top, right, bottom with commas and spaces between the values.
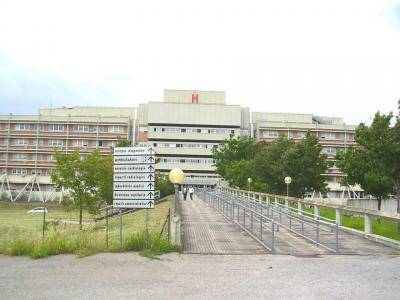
6, 123, 124, 133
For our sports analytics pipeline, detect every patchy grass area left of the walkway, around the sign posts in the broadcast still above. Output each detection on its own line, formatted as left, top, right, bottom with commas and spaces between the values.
0, 199, 181, 258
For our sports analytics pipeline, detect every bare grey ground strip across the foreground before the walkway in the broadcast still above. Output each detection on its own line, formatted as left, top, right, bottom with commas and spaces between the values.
0, 253, 400, 299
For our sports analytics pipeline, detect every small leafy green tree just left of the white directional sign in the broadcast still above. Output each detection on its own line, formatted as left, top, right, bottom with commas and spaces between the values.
51, 150, 113, 229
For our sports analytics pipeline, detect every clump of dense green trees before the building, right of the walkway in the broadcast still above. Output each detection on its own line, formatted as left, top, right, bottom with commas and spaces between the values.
213, 134, 329, 197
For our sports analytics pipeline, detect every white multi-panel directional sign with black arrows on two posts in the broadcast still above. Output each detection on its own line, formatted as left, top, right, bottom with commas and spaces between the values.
113, 147, 156, 248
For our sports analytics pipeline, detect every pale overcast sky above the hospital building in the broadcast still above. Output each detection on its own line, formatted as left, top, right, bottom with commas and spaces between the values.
0, 0, 400, 124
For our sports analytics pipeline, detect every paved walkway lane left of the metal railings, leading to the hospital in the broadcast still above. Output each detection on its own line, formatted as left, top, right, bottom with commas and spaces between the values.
181, 196, 266, 254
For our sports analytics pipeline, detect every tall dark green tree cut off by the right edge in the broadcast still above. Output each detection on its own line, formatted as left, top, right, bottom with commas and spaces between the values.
336, 112, 400, 212
